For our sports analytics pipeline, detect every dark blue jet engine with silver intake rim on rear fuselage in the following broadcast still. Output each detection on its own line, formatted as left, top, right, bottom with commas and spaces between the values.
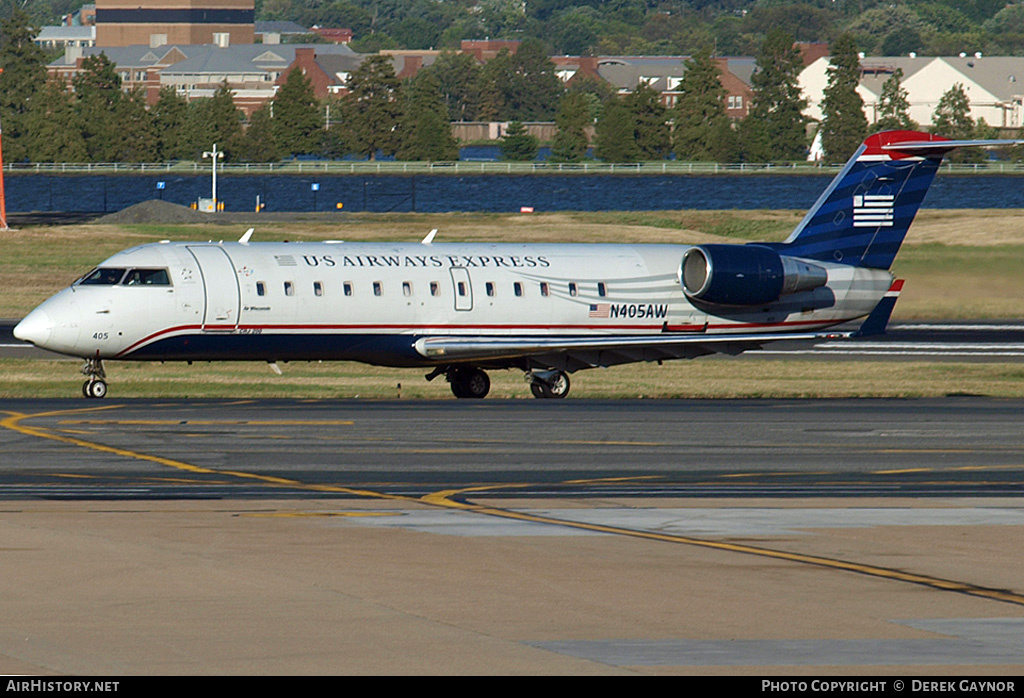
680, 245, 828, 305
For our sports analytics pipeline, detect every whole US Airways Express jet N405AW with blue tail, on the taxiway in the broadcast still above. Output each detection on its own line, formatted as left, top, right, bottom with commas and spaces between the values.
14, 131, 1013, 398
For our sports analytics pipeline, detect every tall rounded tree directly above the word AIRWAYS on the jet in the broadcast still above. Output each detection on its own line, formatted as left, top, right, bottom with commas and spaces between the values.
346, 55, 401, 160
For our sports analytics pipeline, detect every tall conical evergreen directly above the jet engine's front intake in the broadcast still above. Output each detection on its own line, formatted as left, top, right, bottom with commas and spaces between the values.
673, 46, 732, 160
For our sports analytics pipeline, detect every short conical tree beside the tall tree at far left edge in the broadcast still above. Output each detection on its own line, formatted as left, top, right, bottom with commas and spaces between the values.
27, 79, 88, 163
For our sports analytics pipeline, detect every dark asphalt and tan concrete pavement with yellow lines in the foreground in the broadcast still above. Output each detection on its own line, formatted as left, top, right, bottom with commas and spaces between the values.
0, 398, 1024, 678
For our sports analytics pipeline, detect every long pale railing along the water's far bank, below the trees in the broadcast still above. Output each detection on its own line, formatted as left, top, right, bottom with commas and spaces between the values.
3, 160, 1024, 176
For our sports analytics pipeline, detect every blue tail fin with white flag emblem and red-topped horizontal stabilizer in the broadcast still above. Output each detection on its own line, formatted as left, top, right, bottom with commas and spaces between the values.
771, 131, 1016, 269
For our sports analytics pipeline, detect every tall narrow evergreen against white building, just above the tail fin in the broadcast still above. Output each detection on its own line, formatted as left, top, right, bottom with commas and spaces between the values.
821, 34, 867, 162
